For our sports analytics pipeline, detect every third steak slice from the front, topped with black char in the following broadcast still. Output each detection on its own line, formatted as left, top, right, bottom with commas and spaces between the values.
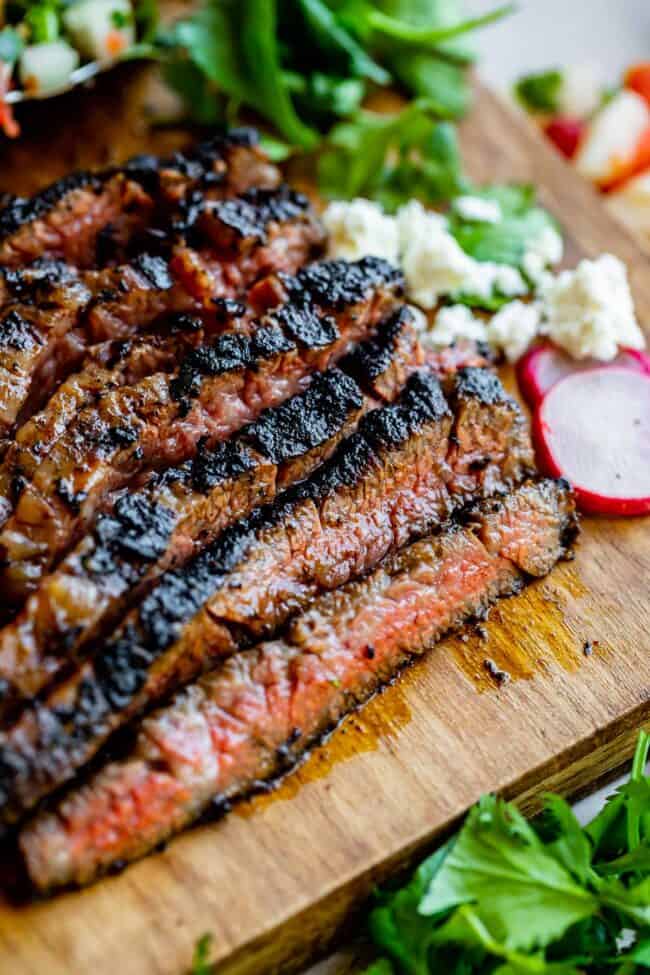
0, 369, 366, 709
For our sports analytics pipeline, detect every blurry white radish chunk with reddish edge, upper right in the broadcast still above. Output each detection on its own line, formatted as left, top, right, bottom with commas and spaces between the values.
576, 91, 650, 187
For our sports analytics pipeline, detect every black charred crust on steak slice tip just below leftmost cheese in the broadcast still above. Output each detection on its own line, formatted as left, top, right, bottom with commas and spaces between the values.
279, 257, 404, 309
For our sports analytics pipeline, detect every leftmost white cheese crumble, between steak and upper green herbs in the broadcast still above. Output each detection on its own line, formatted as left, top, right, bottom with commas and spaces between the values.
323, 198, 399, 264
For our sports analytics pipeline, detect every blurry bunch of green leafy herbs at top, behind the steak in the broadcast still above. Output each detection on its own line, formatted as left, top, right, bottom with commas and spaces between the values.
159, 0, 512, 201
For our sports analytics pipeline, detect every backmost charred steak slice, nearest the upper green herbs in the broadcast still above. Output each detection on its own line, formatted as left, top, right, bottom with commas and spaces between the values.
0, 130, 279, 268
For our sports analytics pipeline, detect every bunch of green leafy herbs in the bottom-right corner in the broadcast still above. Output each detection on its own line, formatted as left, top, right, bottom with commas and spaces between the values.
366, 736, 650, 975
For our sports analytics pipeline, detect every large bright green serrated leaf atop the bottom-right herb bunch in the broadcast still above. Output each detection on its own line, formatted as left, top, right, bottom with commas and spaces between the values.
419, 797, 598, 951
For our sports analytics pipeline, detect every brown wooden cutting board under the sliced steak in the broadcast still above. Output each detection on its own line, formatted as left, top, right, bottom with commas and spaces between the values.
0, 66, 650, 975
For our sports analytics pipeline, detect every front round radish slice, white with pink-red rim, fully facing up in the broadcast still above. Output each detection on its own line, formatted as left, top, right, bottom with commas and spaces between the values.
533, 366, 650, 515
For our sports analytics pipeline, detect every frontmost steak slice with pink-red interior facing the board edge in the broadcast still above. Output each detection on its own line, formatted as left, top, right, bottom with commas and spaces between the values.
20, 481, 576, 891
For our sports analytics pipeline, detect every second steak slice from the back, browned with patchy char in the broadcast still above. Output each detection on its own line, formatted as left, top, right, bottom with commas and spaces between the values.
0, 186, 323, 436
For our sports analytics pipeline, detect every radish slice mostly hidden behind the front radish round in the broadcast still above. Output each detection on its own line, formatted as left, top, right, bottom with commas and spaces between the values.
517, 343, 650, 407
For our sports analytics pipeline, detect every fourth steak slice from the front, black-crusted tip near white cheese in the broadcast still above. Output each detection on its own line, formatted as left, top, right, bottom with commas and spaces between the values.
0, 258, 401, 607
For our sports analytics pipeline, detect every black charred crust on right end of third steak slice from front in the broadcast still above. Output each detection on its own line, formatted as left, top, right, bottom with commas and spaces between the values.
242, 369, 363, 464
